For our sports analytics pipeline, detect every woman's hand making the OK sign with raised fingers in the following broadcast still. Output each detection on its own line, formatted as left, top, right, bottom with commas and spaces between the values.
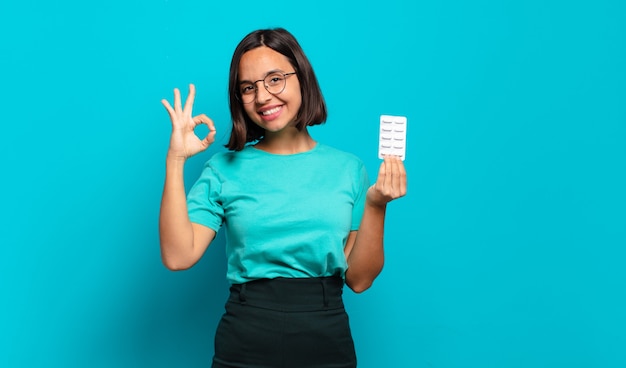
161, 84, 215, 160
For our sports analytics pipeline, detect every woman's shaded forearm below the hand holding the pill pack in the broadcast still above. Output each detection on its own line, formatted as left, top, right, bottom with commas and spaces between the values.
346, 202, 386, 293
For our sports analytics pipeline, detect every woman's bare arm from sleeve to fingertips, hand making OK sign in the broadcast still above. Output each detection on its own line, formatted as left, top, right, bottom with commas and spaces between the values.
159, 85, 215, 270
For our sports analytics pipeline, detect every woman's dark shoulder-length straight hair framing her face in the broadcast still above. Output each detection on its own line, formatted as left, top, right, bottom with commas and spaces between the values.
225, 28, 327, 151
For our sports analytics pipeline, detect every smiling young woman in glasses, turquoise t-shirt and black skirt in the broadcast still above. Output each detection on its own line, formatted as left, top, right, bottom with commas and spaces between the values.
159, 29, 406, 368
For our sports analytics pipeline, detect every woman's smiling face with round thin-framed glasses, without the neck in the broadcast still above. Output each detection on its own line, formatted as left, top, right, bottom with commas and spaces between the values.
238, 46, 302, 135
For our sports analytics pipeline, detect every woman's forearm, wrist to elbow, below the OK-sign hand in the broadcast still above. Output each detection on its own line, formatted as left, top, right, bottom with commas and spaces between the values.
159, 158, 193, 269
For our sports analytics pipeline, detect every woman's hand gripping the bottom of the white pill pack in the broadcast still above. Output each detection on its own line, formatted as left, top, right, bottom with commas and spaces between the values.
367, 156, 406, 207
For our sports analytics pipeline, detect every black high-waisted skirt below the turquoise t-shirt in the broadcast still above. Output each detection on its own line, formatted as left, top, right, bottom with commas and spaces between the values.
213, 277, 356, 368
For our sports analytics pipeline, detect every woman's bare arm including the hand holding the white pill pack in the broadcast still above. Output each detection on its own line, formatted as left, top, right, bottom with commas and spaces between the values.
345, 157, 406, 293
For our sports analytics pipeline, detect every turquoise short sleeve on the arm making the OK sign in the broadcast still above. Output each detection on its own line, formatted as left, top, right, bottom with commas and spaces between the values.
187, 163, 224, 232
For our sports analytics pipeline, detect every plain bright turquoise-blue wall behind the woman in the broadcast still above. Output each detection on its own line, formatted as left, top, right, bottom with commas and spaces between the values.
0, 0, 626, 368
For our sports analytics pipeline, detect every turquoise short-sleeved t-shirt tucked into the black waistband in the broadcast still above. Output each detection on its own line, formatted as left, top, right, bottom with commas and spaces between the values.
187, 143, 369, 284
